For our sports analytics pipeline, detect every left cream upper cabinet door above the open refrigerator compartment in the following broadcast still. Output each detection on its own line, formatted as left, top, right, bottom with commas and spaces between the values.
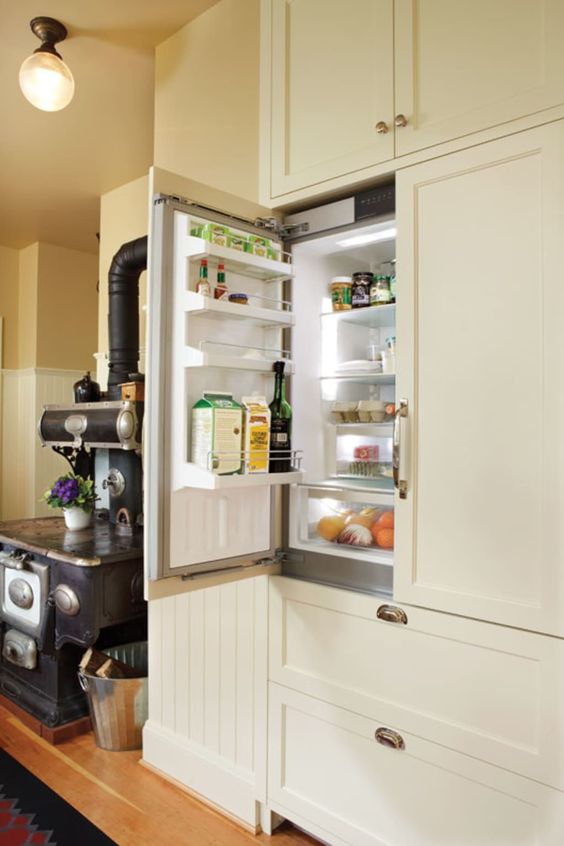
262, 0, 394, 197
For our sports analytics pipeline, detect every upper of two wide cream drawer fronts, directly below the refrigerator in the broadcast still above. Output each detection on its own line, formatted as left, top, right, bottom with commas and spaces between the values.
269, 578, 564, 790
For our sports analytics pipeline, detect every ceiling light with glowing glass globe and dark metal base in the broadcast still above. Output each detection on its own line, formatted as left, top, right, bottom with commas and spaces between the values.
20, 18, 74, 112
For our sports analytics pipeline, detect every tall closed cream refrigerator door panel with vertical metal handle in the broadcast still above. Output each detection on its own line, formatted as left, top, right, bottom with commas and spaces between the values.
394, 121, 564, 637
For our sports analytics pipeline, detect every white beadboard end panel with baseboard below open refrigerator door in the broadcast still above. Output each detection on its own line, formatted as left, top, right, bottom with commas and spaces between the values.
143, 576, 268, 829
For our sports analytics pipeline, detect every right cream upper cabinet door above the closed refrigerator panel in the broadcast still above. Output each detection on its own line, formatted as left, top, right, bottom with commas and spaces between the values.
395, 0, 564, 156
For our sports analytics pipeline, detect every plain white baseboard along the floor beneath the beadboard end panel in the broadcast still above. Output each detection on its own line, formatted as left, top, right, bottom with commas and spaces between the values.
143, 720, 259, 830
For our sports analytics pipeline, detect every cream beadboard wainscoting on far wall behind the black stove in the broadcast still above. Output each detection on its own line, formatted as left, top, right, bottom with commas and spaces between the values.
0, 368, 82, 520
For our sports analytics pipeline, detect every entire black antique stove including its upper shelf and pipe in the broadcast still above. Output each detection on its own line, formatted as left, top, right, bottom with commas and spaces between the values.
0, 237, 147, 729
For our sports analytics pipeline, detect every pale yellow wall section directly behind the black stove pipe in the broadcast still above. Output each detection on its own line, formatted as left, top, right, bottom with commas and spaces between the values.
98, 176, 149, 382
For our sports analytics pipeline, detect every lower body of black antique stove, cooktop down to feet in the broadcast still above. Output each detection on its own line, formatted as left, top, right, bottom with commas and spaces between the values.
0, 517, 146, 728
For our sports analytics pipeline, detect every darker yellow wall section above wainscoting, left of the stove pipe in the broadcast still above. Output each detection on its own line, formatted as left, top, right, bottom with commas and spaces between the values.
35, 243, 98, 371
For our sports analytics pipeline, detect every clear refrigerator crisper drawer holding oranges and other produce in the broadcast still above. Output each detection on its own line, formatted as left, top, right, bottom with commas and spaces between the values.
290, 485, 394, 567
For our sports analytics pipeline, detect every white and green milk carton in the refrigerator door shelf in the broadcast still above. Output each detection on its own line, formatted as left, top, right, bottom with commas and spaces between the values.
192, 391, 243, 476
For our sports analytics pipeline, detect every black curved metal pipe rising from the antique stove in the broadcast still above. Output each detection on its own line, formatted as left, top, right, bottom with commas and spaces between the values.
108, 235, 147, 399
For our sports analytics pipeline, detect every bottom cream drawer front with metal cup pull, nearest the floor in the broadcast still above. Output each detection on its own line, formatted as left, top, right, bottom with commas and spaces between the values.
268, 683, 564, 846
